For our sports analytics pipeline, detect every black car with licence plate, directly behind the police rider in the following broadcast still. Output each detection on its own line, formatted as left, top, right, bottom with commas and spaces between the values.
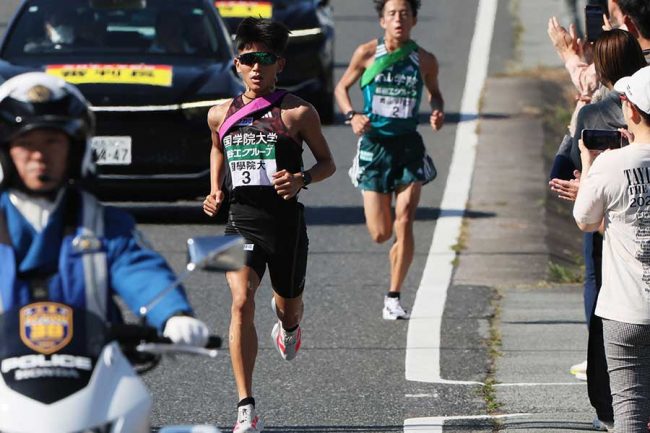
0, 0, 243, 199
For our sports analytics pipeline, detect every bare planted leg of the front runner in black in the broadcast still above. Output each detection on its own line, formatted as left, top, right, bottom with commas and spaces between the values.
226, 266, 260, 400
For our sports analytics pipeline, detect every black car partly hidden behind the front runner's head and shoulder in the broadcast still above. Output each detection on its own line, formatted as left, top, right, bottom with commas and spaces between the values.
215, 0, 334, 123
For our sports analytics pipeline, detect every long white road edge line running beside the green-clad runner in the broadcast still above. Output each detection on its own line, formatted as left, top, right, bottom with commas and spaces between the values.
405, 0, 497, 384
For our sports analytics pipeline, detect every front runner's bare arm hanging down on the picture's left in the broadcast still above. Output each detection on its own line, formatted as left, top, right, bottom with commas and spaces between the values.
203, 103, 229, 216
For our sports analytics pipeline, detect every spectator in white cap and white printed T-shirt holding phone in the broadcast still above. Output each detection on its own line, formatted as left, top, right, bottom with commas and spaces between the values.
573, 67, 650, 432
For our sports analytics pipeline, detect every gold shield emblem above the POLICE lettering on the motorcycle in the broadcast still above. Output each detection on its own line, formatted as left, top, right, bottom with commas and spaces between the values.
20, 302, 73, 355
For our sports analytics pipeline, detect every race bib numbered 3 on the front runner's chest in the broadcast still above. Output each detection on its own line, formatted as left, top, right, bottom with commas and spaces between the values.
223, 132, 278, 188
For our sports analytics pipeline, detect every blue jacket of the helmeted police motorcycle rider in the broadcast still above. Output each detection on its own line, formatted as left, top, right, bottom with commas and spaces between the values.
0, 189, 192, 329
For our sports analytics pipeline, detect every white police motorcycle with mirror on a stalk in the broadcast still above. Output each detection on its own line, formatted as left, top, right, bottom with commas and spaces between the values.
0, 236, 244, 433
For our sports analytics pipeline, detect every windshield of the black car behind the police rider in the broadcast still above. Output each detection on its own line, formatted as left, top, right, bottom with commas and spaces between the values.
3, 0, 230, 61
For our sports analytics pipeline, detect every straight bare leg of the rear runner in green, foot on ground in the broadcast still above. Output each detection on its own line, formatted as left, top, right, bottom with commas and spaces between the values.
389, 182, 422, 292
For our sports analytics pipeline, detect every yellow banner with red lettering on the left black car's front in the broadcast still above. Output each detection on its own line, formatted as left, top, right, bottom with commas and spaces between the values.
45, 64, 173, 87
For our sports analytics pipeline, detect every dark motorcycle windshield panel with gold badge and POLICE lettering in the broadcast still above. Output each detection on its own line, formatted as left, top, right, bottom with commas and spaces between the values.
0, 302, 108, 404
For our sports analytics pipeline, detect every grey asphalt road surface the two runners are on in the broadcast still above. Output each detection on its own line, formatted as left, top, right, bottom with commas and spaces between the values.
132, 0, 510, 433
